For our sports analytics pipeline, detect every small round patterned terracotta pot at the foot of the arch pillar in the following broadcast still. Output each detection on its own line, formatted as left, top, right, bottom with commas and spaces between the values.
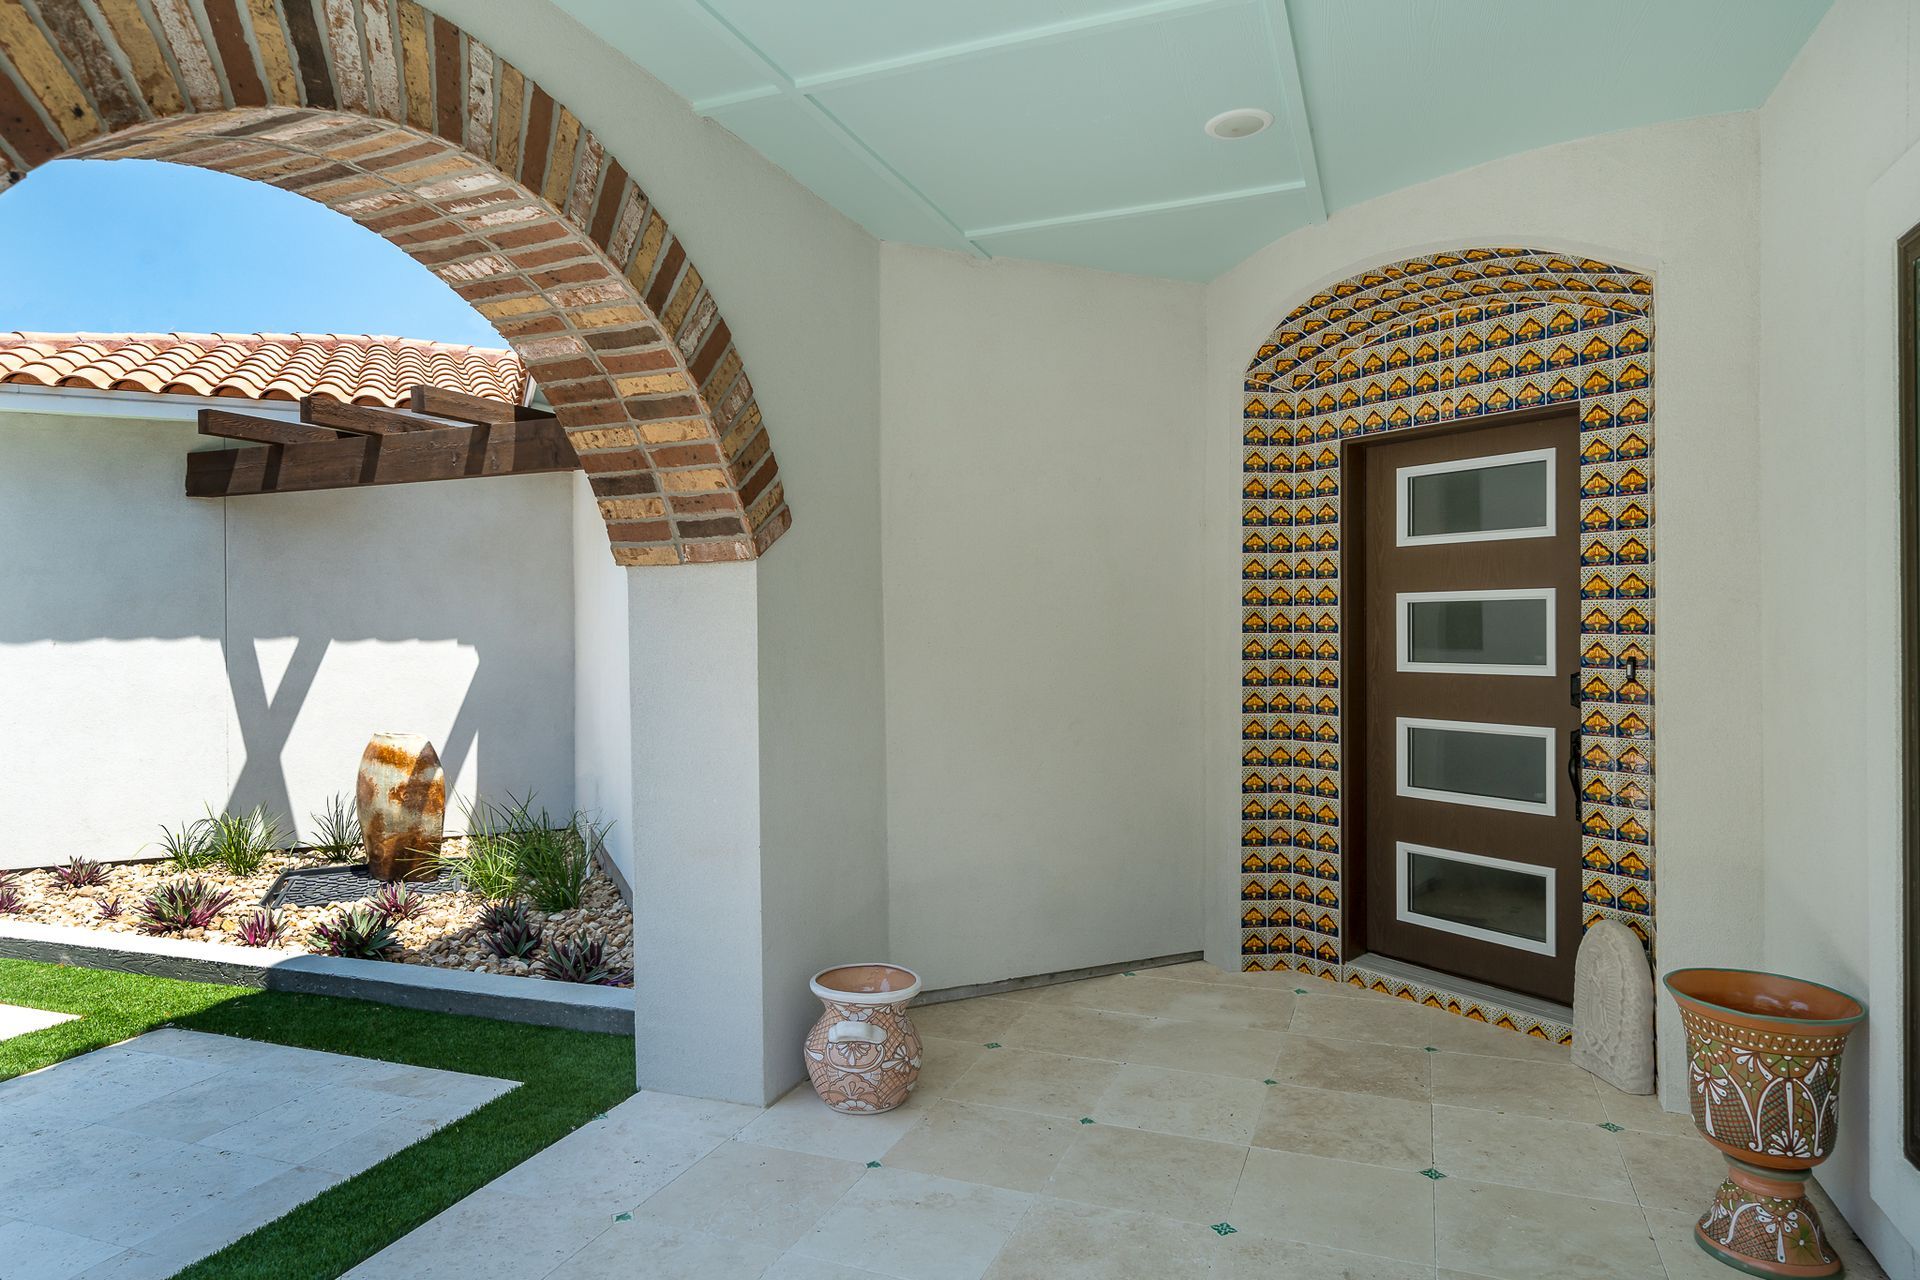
806, 965, 920, 1115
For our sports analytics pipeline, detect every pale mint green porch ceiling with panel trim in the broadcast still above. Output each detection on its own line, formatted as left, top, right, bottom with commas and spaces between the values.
555, 0, 1830, 280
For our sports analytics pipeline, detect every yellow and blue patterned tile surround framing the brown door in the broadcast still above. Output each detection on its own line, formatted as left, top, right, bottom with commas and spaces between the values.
1240, 248, 1655, 1042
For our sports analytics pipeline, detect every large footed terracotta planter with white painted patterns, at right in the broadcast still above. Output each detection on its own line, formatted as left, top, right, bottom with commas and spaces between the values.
1667, 969, 1866, 1276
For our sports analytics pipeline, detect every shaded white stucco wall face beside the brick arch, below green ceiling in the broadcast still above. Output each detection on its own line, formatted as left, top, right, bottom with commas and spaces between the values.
432, 0, 887, 1105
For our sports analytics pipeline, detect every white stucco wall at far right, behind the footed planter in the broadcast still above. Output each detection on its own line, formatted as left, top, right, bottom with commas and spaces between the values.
1757, 0, 1920, 1280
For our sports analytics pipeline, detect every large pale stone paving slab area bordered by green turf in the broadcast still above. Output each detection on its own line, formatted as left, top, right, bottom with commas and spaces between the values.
0, 1029, 513, 1280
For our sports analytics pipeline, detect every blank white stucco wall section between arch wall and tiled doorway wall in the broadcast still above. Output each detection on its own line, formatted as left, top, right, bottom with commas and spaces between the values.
881, 244, 1202, 988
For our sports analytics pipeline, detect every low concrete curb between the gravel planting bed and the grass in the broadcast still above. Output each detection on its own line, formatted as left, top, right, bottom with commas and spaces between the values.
0, 923, 634, 1036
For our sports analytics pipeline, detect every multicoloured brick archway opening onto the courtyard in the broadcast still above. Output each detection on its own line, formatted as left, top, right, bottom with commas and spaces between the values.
0, 0, 791, 564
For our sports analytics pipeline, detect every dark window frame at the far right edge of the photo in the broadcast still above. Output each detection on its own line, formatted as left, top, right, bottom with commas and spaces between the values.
1899, 226, 1920, 1167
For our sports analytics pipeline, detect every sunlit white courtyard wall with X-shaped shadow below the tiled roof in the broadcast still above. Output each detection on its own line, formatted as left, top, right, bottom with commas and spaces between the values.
0, 391, 574, 865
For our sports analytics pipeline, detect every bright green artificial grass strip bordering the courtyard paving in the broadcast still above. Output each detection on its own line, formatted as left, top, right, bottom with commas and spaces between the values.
0, 960, 634, 1280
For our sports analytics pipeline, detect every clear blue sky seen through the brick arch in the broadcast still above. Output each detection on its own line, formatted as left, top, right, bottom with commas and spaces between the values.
0, 159, 507, 347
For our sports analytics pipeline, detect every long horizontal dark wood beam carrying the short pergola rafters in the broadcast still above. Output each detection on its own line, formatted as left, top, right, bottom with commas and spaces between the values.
186, 420, 580, 497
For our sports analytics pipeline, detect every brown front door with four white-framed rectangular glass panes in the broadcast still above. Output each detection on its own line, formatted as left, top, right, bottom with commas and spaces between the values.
1348, 415, 1580, 1004
